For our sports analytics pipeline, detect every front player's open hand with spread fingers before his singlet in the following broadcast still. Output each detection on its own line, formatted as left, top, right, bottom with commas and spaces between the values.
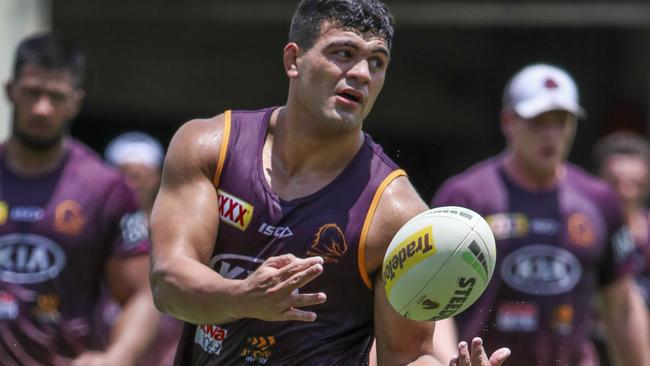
241, 254, 327, 322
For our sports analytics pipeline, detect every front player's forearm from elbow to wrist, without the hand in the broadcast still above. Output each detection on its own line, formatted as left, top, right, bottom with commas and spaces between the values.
151, 258, 242, 324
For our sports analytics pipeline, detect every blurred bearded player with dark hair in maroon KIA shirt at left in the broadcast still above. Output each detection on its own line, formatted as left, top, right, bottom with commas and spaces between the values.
0, 34, 159, 365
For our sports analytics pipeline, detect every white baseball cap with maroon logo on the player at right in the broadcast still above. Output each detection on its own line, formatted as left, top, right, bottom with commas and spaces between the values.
503, 64, 586, 118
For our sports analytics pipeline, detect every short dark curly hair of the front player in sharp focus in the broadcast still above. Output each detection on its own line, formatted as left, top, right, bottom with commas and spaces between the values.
289, 0, 395, 49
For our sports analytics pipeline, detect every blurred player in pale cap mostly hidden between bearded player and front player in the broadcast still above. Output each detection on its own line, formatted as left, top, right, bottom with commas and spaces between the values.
98, 132, 183, 366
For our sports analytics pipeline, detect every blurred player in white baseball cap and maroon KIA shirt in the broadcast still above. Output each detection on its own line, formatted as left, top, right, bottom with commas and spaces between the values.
432, 64, 649, 366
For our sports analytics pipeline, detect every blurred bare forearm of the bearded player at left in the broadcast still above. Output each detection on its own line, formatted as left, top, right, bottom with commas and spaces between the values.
106, 287, 160, 365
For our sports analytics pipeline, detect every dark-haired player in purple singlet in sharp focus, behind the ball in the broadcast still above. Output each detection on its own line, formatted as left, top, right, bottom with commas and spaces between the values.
151, 0, 508, 365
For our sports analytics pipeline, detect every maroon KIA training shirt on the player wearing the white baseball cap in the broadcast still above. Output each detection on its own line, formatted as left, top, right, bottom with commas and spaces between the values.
432, 157, 633, 366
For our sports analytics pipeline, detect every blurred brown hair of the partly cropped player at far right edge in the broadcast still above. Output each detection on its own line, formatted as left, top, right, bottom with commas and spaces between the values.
593, 131, 650, 170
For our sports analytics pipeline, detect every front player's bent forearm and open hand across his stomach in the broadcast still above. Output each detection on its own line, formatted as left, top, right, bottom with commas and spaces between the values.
151, 254, 327, 324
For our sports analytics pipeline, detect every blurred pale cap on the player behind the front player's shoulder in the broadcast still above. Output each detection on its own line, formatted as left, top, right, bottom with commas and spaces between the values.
104, 132, 164, 168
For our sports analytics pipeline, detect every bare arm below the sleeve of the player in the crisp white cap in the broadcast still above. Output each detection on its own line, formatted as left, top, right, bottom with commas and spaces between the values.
600, 277, 650, 365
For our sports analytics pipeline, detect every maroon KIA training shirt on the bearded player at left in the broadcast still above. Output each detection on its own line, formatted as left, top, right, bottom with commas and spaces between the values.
0, 139, 149, 365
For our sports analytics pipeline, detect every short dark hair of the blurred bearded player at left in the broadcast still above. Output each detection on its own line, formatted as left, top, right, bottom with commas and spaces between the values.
13, 33, 86, 87
